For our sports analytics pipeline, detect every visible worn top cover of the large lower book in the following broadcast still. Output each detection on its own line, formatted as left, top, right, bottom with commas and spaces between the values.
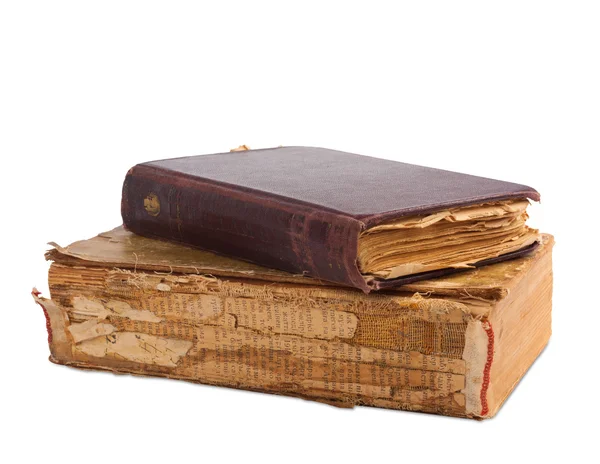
46, 226, 554, 300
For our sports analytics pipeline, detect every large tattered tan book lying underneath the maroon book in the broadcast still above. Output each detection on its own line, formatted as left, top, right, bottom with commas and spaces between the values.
34, 228, 553, 418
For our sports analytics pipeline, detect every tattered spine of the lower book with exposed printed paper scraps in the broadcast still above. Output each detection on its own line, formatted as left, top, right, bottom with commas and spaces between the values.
41, 263, 474, 416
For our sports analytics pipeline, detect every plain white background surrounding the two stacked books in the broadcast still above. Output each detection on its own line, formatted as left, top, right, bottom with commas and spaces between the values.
0, 0, 600, 463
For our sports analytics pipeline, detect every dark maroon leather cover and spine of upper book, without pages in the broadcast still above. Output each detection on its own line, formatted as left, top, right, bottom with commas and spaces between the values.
121, 147, 539, 292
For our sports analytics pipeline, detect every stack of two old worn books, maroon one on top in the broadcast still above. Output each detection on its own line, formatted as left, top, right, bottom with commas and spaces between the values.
33, 147, 553, 419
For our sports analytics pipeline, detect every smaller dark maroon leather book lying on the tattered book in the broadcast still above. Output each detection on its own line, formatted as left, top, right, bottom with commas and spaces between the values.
121, 147, 539, 293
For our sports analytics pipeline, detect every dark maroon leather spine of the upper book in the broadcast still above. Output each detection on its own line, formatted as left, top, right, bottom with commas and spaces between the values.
121, 165, 370, 293
